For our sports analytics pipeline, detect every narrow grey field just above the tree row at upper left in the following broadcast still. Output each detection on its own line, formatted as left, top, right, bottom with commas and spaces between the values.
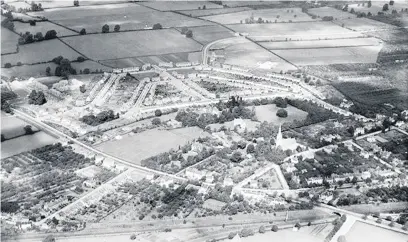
14, 21, 77, 37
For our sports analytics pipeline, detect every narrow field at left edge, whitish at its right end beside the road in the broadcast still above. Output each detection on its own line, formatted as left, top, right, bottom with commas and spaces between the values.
1, 132, 57, 159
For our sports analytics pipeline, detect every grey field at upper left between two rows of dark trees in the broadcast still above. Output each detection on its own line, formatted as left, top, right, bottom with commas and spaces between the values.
1, 39, 82, 65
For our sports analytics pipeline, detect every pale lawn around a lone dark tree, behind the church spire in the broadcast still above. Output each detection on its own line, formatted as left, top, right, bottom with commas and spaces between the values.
255, 104, 307, 124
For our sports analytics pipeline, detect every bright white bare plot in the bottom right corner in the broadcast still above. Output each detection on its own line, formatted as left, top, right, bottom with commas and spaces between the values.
345, 222, 407, 242
